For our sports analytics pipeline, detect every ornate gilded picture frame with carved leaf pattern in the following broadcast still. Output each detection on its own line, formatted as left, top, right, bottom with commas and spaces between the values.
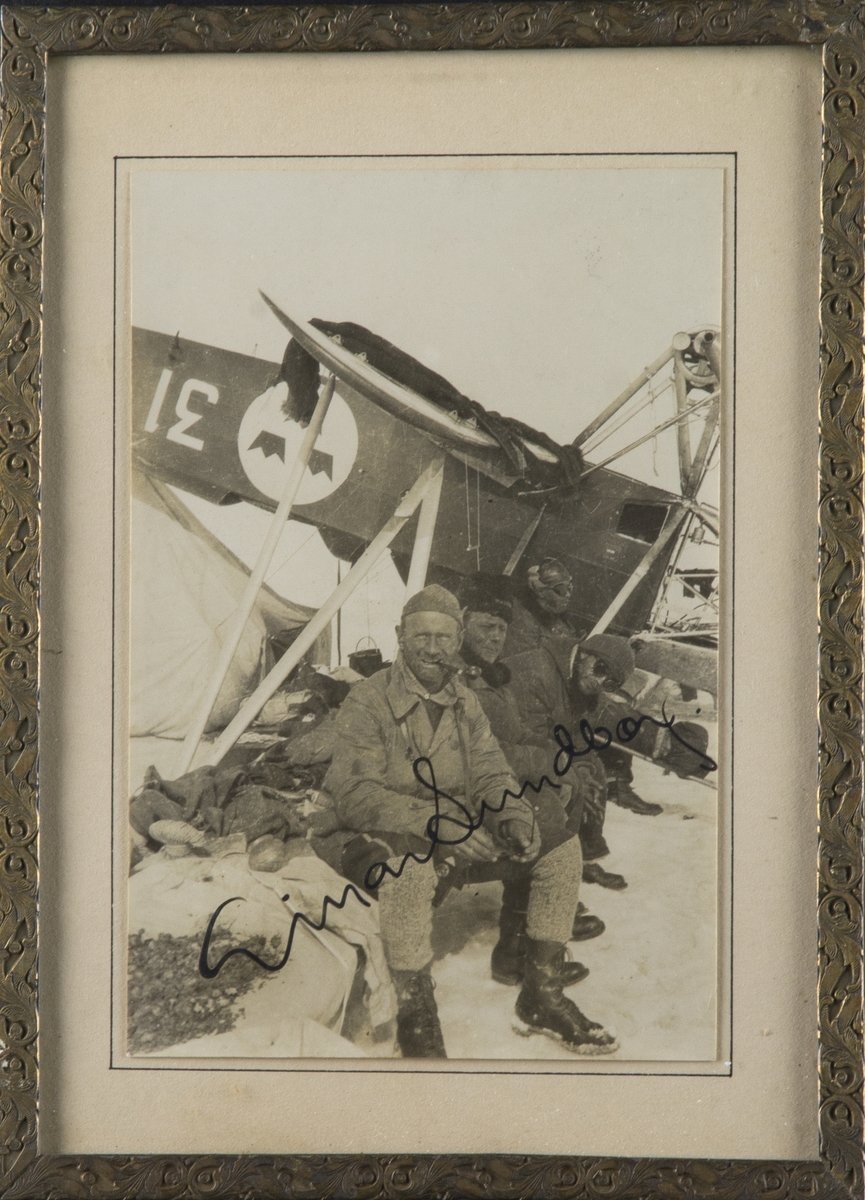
0, 0, 865, 1200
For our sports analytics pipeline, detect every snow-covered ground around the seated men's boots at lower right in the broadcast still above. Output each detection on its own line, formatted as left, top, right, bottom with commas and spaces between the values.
433, 761, 717, 1067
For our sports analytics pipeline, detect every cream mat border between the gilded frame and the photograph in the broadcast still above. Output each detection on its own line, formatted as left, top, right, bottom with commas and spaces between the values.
41, 49, 819, 1158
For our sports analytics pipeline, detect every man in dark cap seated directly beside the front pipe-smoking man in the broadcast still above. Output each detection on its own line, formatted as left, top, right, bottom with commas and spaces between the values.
459, 575, 605, 950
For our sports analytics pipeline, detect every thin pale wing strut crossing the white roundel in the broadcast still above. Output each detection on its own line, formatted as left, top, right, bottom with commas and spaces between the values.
175, 374, 336, 778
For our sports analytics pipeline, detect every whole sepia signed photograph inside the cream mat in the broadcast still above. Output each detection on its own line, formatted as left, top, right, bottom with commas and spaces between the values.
121, 154, 734, 1074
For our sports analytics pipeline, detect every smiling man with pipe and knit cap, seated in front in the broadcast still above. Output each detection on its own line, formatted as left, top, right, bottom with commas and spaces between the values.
324, 586, 615, 1057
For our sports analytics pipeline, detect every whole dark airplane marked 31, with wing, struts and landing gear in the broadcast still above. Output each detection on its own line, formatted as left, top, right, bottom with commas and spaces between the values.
132, 296, 721, 767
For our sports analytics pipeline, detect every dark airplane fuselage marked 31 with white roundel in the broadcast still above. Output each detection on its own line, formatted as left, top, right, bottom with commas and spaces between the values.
132, 324, 695, 634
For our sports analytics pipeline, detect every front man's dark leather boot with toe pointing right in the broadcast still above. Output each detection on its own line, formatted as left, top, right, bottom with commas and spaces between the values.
513, 937, 619, 1055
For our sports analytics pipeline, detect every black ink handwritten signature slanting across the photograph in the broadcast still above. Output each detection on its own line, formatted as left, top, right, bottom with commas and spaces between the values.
198, 713, 717, 979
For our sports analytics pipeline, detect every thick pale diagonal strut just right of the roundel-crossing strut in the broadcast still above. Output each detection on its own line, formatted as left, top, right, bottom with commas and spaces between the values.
202, 457, 444, 767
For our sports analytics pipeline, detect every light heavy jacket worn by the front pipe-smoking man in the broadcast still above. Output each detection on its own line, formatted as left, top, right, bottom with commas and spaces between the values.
323, 655, 531, 838
